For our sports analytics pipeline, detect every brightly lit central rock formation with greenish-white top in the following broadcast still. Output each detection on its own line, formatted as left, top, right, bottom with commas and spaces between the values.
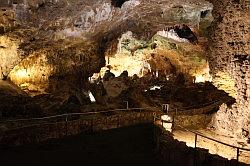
97, 29, 211, 82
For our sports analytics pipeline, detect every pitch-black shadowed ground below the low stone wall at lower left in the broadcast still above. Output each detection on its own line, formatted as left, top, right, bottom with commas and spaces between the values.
0, 124, 162, 166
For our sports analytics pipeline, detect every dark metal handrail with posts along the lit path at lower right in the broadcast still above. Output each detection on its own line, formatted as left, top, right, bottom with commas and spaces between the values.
154, 115, 250, 165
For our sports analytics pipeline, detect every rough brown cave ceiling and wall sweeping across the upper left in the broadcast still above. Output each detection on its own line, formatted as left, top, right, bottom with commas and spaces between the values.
0, 0, 212, 93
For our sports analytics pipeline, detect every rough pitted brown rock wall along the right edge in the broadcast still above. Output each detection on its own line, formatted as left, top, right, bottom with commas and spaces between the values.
209, 0, 250, 139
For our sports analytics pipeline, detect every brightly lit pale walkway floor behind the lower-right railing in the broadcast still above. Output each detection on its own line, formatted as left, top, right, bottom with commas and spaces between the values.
174, 129, 250, 164
